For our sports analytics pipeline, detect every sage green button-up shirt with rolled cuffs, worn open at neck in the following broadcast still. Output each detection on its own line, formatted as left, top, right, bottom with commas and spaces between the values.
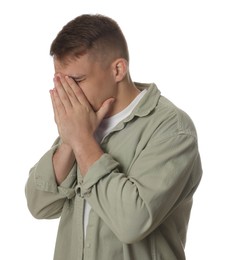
26, 83, 202, 260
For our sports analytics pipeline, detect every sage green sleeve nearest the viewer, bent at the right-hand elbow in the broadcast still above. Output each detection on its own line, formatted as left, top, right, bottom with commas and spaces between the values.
77, 134, 200, 243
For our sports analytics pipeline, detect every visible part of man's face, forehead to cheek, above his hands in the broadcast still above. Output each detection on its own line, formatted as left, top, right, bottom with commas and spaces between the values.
54, 54, 116, 111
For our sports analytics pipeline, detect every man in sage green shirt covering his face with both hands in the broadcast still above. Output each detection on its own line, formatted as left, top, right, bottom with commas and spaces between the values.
26, 15, 202, 260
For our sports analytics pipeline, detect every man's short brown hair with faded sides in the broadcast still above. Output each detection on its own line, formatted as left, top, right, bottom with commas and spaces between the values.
50, 14, 129, 61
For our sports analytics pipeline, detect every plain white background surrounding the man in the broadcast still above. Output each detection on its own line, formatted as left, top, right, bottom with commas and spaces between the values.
0, 0, 227, 260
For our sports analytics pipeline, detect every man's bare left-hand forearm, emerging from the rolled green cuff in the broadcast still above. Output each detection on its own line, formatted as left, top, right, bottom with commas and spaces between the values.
52, 143, 75, 185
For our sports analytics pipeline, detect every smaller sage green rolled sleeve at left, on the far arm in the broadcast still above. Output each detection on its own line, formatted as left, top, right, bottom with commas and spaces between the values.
25, 138, 76, 218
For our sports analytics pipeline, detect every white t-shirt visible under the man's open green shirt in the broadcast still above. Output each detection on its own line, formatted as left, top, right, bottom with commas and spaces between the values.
84, 89, 147, 238
